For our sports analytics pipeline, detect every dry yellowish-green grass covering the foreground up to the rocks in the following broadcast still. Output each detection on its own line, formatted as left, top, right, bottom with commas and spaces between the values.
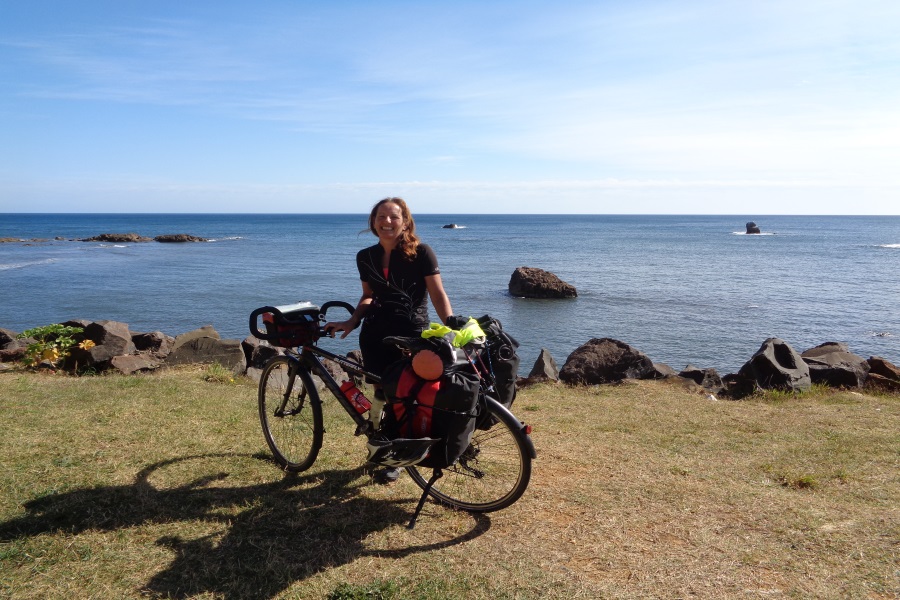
0, 370, 900, 599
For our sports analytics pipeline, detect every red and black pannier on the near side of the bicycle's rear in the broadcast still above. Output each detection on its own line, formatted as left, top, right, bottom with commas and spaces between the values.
381, 359, 479, 469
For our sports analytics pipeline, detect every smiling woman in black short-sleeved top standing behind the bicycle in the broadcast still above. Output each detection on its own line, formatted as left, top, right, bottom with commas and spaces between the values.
325, 198, 453, 481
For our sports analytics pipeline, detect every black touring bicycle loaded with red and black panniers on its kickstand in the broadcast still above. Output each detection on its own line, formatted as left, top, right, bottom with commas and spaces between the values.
250, 301, 537, 528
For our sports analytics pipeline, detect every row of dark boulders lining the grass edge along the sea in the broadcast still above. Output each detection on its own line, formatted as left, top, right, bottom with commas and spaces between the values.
0, 320, 900, 399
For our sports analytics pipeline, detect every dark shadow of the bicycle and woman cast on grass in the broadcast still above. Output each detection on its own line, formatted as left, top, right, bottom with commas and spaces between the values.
0, 454, 490, 600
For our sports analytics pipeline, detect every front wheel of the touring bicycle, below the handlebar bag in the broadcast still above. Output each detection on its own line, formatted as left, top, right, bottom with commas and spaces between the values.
259, 356, 325, 472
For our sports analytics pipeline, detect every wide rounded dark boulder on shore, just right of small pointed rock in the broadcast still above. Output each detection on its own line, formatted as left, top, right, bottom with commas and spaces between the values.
559, 338, 654, 385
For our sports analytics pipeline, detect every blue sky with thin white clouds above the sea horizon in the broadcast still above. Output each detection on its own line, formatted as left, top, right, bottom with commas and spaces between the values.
0, 0, 900, 215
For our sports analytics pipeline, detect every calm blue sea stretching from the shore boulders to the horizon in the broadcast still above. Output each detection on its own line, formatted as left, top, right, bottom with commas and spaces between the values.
0, 214, 900, 374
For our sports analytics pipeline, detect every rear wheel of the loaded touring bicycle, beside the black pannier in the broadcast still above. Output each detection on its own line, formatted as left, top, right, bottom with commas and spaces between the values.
406, 397, 533, 513
